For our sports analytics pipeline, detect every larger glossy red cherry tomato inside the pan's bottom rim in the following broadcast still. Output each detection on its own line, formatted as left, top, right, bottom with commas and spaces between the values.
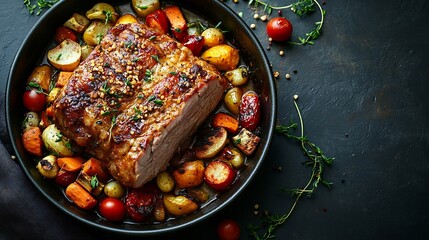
98, 197, 126, 222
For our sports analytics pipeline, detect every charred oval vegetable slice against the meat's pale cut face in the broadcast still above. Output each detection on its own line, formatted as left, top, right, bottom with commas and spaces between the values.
194, 128, 228, 159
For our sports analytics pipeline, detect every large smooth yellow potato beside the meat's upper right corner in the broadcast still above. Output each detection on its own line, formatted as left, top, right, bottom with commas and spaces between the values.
201, 44, 240, 71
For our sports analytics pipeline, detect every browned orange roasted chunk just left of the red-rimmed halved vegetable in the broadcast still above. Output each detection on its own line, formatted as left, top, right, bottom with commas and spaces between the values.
173, 160, 205, 188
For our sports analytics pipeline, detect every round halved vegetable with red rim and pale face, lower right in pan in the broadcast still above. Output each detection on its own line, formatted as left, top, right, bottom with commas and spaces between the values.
204, 160, 237, 191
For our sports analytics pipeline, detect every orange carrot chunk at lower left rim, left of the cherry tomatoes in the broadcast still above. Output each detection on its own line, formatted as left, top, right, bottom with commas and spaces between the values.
66, 182, 97, 210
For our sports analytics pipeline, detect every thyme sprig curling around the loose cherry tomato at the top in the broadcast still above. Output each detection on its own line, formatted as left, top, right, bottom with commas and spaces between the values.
249, 0, 326, 45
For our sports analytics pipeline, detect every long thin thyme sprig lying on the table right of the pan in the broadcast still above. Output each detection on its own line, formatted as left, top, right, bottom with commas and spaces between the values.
248, 100, 334, 240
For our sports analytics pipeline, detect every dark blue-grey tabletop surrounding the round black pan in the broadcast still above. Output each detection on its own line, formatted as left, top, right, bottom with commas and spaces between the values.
0, 0, 429, 240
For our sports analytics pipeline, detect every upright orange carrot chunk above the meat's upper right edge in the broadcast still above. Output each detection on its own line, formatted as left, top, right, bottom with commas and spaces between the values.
164, 6, 188, 42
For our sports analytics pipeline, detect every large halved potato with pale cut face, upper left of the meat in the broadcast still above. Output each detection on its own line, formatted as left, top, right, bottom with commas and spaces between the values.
48, 39, 82, 72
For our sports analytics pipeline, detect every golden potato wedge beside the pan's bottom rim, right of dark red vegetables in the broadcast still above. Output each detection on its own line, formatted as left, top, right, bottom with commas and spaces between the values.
163, 195, 198, 216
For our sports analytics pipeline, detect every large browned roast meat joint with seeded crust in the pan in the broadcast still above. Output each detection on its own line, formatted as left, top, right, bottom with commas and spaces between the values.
53, 23, 226, 187
